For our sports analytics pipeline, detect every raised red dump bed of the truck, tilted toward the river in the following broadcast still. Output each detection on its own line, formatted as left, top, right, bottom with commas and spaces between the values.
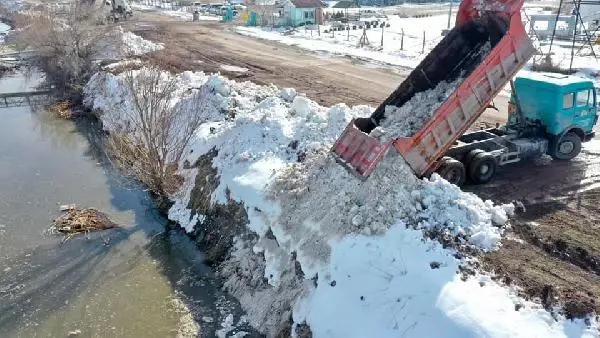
332, 0, 535, 178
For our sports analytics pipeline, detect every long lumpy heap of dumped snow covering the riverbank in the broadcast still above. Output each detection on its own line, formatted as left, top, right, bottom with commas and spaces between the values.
85, 68, 596, 337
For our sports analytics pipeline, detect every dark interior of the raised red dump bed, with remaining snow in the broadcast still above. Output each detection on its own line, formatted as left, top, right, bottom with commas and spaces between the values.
357, 15, 503, 136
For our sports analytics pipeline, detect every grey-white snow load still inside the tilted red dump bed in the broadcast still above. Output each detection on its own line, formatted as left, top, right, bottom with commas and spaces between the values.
372, 78, 462, 140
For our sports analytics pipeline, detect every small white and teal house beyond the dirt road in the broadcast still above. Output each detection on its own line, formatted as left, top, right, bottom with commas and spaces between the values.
282, 0, 323, 27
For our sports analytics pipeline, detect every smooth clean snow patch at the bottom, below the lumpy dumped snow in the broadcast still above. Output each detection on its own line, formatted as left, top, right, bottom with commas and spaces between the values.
294, 223, 592, 338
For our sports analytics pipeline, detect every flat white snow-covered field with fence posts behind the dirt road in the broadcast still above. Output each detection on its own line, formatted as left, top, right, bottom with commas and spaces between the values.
236, 10, 600, 79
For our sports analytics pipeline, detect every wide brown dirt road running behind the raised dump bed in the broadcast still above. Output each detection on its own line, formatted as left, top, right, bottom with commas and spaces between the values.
129, 12, 507, 124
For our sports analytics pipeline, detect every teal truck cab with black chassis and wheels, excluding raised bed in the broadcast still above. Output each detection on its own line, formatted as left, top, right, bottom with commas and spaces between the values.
438, 71, 598, 185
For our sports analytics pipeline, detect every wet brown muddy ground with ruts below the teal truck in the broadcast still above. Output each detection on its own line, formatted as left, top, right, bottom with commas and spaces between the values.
467, 144, 600, 317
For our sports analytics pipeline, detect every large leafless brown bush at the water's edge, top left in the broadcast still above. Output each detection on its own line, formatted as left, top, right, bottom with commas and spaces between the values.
17, 4, 114, 101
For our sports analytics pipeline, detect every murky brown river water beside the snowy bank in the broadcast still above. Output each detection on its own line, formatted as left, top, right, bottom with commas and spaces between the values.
0, 72, 252, 337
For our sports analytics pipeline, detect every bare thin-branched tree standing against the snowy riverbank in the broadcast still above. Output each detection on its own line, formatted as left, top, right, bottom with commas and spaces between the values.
105, 68, 209, 196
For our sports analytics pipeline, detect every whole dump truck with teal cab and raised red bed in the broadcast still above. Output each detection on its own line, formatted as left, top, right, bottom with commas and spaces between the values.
331, 0, 598, 185
